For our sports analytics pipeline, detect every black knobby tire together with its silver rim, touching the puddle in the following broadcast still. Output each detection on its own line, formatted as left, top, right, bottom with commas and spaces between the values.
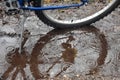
35, 0, 120, 28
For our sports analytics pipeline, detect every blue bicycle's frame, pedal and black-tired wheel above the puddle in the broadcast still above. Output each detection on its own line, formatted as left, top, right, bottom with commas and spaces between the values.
1, 0, 120, 28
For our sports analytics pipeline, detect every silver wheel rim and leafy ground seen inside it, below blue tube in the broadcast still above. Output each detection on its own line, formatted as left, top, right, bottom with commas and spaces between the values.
42, 0, 116, 24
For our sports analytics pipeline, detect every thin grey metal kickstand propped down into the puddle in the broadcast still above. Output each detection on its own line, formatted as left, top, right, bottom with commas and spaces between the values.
19, 11, 28, 54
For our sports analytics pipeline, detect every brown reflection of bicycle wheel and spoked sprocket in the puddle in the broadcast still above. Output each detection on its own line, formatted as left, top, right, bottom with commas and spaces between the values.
2, 26, 108, 80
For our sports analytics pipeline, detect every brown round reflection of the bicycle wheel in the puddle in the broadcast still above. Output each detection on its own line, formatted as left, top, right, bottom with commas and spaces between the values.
30, 27, 107, 79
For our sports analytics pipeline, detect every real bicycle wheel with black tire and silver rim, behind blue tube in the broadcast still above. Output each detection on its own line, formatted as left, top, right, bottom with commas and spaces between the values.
34, 0, 120, 28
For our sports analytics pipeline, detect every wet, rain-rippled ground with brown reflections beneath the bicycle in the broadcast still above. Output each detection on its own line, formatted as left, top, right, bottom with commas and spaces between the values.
0, 8, 120, 80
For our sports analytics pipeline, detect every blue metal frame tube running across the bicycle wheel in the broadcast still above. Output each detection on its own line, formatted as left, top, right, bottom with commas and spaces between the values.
18, 0, 88, 10
